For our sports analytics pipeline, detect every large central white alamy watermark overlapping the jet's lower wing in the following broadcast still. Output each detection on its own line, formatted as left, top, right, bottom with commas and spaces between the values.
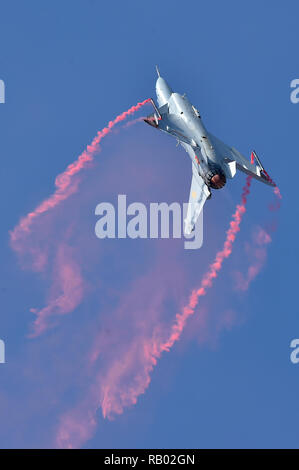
95, 194, 203, 250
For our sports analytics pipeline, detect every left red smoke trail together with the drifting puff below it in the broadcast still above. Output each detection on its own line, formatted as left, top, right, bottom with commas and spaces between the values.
10, 99, 150, 337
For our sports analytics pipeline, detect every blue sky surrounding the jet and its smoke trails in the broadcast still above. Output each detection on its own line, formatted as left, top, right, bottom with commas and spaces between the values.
0, 0, 299, 448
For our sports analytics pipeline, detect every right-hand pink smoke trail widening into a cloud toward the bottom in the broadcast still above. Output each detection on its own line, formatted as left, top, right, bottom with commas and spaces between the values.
56, 176, 284, 447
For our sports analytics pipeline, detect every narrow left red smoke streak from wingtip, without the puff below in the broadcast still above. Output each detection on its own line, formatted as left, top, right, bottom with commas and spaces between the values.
10, 98, 150, 250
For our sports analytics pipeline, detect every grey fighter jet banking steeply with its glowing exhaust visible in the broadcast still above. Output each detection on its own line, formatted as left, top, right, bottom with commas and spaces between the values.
144, 67, 275, 234
